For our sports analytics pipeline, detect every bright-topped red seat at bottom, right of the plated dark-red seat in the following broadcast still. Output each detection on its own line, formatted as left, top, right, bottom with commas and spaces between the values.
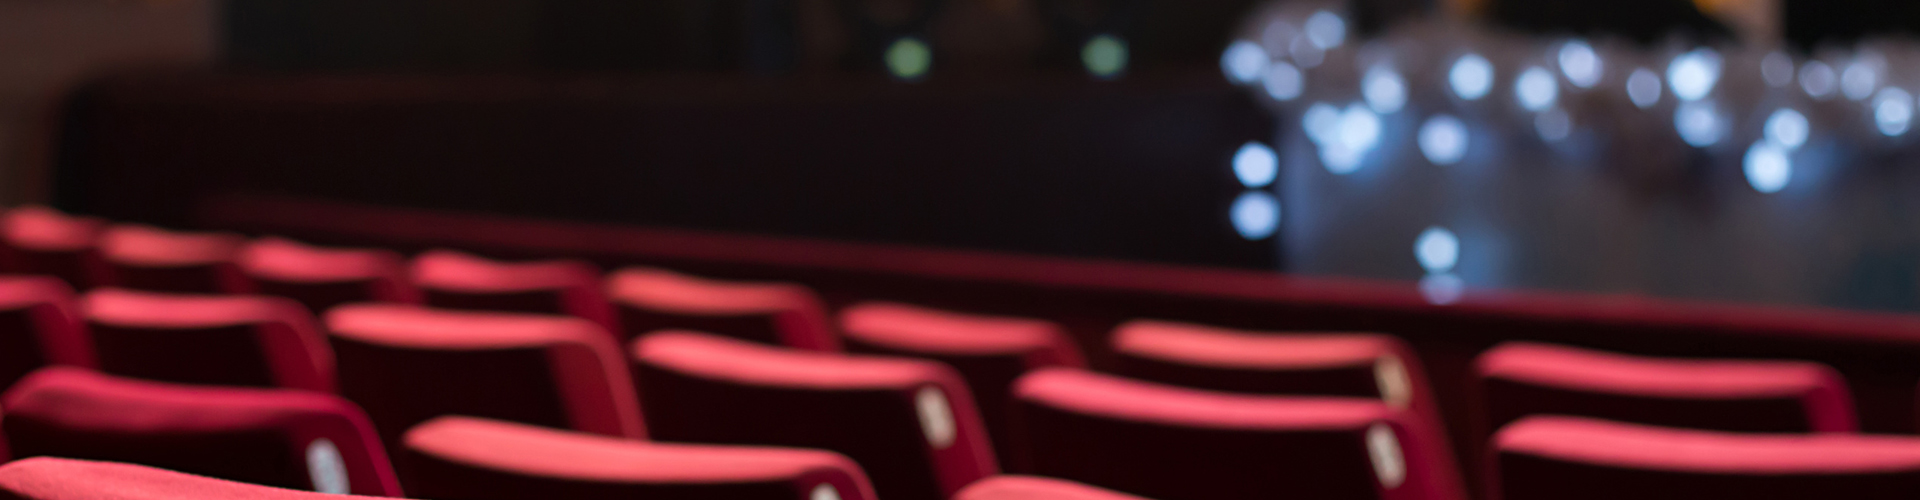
403, 417, 874, 500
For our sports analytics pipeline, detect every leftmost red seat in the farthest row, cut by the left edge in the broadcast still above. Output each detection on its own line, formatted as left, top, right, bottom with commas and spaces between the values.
0, 206, 108, 287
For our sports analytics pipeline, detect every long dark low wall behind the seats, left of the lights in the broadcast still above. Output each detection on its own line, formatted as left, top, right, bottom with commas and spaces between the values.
58, 69, 1279, 269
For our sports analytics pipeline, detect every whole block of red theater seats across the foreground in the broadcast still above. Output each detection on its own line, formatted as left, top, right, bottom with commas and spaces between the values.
0, 204, 1920, 500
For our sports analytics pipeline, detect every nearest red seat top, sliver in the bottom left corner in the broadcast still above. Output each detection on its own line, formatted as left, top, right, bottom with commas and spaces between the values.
0, 456, 399, 500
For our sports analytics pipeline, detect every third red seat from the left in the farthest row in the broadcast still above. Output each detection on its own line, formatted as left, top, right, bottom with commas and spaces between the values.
240, 238, 420, 313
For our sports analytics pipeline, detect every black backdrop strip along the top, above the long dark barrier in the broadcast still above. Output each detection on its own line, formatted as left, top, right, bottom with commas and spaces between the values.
225, 0, 1267, 73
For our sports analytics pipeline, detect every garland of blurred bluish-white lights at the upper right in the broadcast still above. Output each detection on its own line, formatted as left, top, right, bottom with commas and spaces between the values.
1221, 4, 1920, 269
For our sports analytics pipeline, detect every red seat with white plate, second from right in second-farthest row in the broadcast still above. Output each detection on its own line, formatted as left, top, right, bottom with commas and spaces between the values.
1012, 367, 1463, 500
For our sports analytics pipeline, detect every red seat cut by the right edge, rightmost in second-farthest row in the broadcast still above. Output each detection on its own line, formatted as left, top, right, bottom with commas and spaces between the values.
1490, 415, 1920, 500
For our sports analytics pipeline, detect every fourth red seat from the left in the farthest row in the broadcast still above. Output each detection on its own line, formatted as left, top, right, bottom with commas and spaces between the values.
409, 250, 620, 333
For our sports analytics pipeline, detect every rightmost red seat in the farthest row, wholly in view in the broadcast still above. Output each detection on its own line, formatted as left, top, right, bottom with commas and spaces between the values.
1475, 342, 1859, 437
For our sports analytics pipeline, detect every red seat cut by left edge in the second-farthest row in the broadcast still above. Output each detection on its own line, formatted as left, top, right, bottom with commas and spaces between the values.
0, 275, 98, 387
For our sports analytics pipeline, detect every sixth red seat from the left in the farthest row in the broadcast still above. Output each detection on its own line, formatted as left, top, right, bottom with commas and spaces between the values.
839, 302, 1087, 463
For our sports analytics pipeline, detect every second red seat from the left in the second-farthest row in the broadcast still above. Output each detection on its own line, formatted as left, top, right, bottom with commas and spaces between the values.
81, 288, 334, 392
